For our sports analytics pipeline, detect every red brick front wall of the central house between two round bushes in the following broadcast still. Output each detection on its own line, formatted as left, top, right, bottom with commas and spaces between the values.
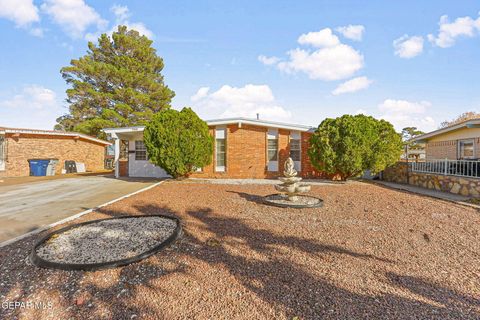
191, 124, 323, 179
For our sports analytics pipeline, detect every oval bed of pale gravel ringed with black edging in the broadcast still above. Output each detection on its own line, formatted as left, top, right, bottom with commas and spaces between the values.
32, 215, 179, 270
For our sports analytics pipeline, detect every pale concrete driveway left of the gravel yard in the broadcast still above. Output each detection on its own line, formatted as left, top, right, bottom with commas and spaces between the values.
0, 175, 158, 242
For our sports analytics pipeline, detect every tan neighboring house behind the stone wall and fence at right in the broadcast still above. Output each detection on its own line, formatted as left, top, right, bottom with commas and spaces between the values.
412, 119, 480, 161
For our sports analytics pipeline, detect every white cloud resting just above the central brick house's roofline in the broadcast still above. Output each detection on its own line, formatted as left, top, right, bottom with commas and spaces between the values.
191, 84, 292, 120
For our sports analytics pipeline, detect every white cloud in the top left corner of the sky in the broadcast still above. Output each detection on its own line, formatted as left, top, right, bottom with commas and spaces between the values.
0, 0, 40, 27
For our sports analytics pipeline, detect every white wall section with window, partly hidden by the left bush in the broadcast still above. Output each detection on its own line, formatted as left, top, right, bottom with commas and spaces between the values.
128, 140, 170, 178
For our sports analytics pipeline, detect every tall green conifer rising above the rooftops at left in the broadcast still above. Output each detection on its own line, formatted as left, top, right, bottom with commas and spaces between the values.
55, 26, 175, 137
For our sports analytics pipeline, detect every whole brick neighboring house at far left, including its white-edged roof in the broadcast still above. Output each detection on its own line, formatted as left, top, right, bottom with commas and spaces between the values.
0, 127, 110, 177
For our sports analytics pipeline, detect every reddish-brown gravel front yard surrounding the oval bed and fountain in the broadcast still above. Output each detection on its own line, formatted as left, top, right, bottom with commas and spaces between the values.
0, 181, 480, 320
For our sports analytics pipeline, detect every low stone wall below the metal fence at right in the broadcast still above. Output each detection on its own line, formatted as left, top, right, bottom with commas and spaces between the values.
382, 162, 480, 198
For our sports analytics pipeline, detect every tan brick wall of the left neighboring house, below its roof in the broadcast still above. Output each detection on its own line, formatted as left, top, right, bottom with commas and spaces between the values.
5, 134, 105, 177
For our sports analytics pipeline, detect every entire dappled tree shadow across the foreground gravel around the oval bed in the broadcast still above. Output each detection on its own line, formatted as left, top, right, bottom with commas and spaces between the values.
0, 204, 480, 319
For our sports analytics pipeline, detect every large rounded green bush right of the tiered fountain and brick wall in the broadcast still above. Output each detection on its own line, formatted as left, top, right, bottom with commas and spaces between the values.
307, 114, 402, 180
